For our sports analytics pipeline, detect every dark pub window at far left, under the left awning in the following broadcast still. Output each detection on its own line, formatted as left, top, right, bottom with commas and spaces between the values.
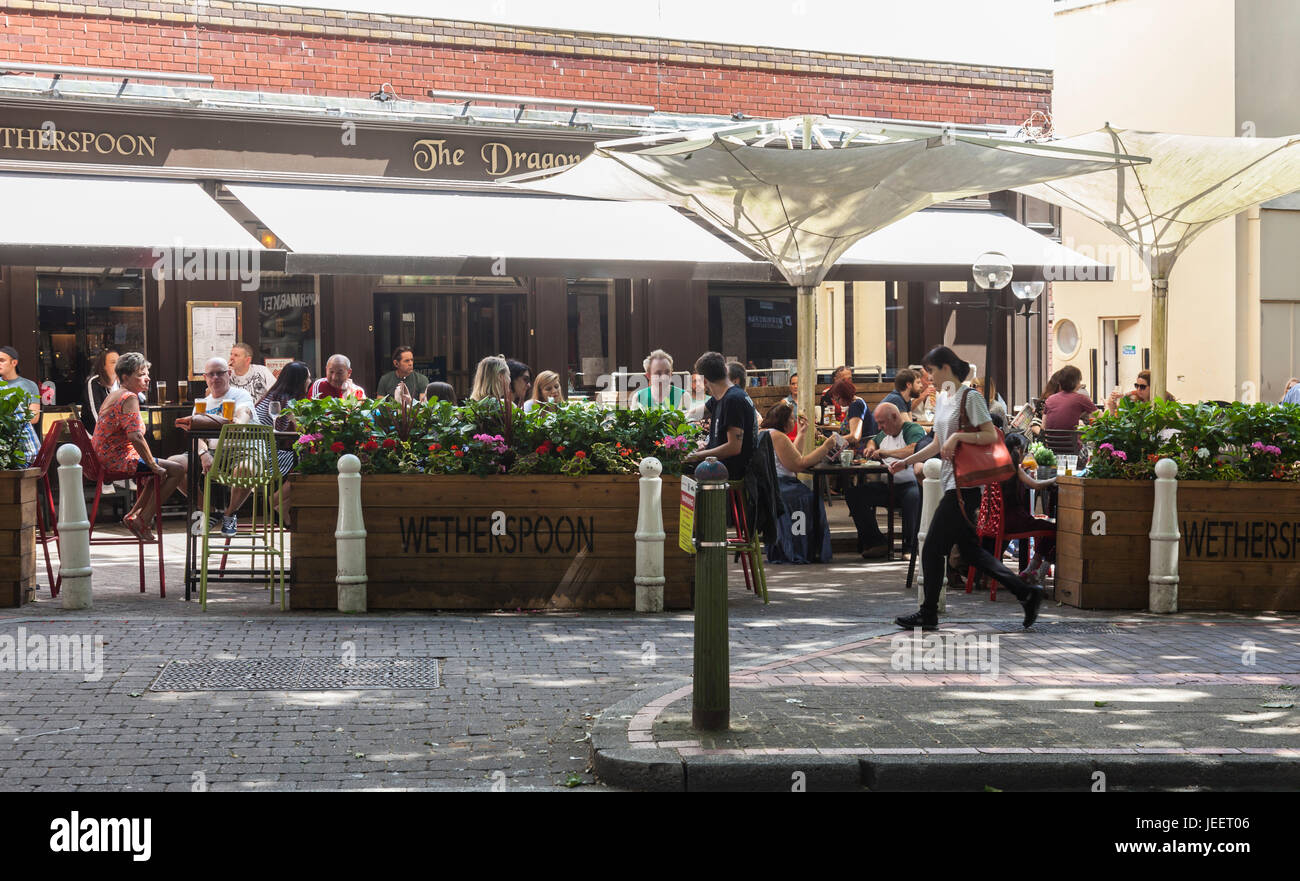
36, 269, 143, 404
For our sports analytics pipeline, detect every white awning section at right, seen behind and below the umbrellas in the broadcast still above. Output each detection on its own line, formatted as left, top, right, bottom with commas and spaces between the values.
828, 209, 1114, 281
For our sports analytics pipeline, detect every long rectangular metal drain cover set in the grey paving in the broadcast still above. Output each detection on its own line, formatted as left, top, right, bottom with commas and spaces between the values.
150, 658, 442, 691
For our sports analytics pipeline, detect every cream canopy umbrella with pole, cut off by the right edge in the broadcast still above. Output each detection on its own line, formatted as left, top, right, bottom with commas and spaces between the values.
1015, 125, 1300, 396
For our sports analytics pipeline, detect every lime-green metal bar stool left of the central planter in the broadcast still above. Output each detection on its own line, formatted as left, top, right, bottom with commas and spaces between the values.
199, 424, 286, 612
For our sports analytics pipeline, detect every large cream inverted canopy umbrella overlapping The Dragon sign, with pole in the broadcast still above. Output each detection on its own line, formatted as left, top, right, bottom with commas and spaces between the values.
506, 116, 1141, 441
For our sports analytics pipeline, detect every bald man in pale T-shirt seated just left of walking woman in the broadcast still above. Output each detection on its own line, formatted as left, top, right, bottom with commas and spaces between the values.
844, 402, 926, 559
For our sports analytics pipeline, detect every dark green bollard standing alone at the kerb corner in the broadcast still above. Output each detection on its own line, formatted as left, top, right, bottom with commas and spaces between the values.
690, 456, 731, 732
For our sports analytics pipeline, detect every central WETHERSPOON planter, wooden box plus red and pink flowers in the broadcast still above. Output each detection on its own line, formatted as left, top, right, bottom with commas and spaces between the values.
290, 399, 698, 609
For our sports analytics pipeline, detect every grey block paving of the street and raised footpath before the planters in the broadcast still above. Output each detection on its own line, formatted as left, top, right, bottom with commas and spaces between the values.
0, 524, 1300, 791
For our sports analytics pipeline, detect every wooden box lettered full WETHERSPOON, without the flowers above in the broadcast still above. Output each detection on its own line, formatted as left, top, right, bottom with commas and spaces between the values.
290, 474, 696, 609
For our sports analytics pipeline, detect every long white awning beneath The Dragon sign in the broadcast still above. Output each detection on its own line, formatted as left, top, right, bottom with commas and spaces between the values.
228, 183, 771, 281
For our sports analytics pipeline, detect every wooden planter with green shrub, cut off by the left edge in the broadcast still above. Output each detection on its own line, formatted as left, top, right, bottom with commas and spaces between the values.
0, 389, 40, 607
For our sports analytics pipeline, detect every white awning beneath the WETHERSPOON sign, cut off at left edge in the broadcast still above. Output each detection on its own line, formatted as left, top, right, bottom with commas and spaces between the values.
0, 174, 274, 269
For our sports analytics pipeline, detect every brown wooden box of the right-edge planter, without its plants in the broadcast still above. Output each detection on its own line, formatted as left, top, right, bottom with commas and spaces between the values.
1057, 477, 1300, 612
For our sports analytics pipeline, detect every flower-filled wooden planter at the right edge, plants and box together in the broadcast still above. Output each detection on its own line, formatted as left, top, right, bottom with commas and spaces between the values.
1057, 400, 1300, 611
